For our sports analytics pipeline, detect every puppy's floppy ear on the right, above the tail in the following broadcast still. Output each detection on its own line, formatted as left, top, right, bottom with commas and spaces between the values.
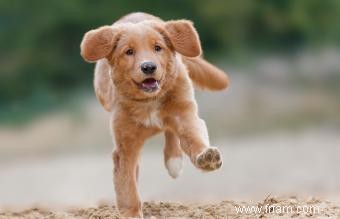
165, 20, 202, 57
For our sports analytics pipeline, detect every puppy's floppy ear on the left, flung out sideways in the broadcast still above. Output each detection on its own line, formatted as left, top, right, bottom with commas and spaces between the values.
80, 26, 119, 62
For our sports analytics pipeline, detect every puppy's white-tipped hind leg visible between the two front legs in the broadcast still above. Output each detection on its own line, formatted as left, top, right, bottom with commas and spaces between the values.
164, 130, 183, 178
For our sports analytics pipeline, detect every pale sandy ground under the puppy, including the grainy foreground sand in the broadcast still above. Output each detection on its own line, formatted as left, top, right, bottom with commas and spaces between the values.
0, 132, 340, 219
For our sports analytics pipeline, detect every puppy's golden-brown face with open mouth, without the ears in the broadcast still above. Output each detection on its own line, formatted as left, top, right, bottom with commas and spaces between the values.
110, 24, 174, 98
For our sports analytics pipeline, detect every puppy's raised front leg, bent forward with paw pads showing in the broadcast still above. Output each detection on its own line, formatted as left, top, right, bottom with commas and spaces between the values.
172, 113, 222, 171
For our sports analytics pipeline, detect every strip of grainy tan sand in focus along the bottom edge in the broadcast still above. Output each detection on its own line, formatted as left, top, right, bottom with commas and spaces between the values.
0, 197, 340, 219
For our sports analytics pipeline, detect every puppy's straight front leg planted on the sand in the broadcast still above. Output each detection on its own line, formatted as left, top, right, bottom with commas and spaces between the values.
113, 121, 145, 218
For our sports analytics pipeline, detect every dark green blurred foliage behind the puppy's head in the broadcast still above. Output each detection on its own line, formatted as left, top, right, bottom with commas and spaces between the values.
0, 0, 340, 119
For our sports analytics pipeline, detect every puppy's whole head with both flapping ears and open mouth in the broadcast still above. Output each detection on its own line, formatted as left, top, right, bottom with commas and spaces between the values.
80, 20, 201, 99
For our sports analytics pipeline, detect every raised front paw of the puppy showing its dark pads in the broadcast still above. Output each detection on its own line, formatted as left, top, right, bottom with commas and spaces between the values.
195, 147, 222, 171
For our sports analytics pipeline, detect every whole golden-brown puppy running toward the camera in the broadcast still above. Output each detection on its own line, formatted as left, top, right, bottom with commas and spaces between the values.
80, 13, 229, 218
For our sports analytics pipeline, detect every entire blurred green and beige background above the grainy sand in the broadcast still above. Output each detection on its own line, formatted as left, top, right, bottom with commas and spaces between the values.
0, 0, 340, 208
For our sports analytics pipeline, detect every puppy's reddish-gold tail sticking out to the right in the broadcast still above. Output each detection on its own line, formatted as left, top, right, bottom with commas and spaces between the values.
183, 57, 229, 91
